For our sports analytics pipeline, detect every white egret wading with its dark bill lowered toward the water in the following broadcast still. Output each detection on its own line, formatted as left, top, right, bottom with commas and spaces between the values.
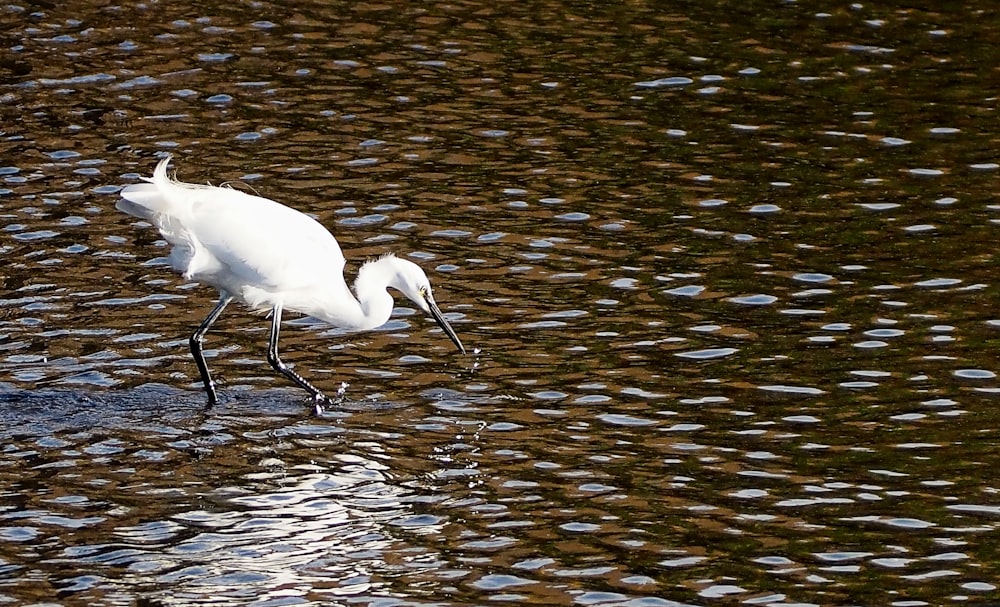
115, 156, 465, 414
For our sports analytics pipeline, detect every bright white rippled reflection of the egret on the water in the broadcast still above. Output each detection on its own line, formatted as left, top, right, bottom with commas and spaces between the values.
122, 458, 444, 605
